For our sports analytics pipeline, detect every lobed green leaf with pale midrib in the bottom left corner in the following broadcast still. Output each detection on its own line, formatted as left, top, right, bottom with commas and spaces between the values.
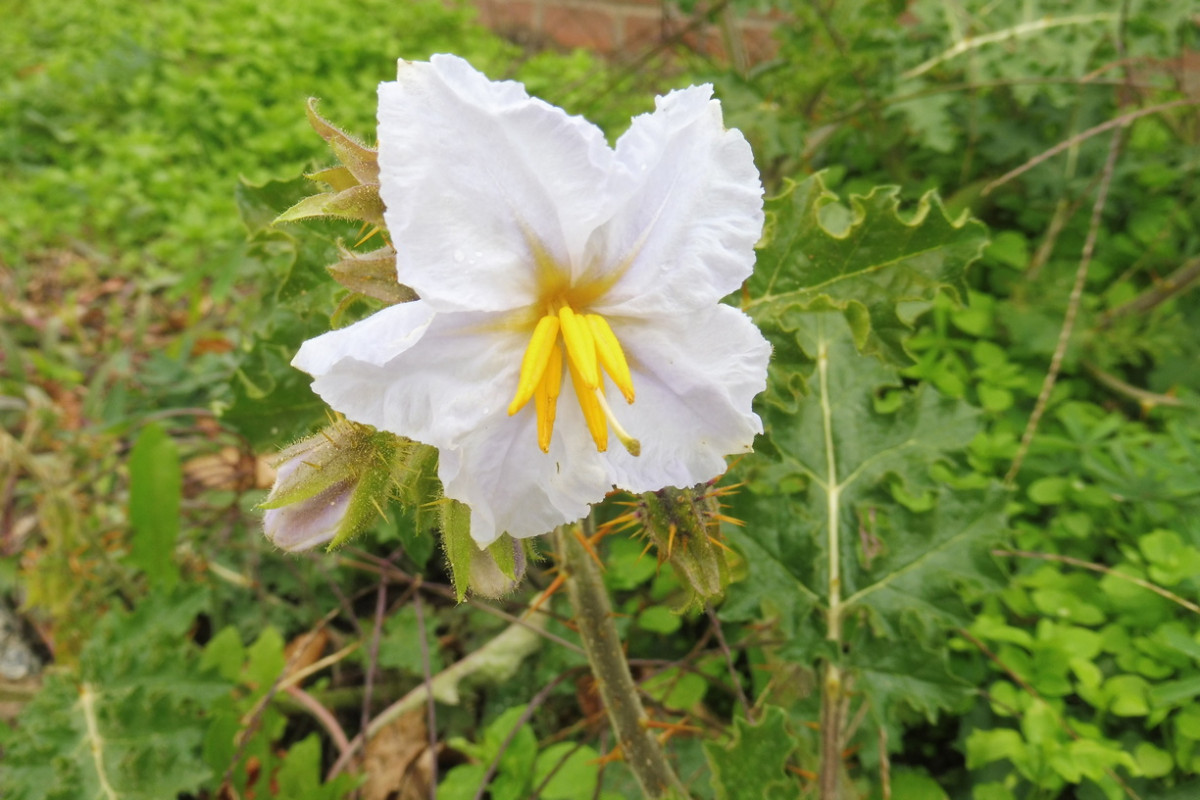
0, 590, 225, 800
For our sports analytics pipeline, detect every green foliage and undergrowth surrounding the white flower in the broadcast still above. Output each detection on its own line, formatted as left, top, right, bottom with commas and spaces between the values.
0, 0, 1200, 800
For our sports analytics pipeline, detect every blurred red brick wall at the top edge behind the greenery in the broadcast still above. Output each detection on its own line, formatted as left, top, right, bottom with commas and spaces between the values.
473, 0, 775, 67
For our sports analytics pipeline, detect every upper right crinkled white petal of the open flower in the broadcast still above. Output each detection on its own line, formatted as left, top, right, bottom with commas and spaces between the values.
588, 85, 763, 314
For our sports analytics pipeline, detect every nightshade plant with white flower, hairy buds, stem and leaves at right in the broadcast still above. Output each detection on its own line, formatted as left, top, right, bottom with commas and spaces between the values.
265, 55, 1003, 798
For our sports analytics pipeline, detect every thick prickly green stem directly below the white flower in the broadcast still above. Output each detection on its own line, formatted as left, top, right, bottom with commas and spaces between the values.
554, 525, 688, 800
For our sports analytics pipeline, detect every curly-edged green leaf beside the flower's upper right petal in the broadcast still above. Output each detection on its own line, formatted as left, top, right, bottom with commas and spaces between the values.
744, 174, 986, 365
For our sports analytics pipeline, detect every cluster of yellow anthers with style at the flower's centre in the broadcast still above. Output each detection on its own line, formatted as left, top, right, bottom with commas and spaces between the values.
509, 301, 642, 456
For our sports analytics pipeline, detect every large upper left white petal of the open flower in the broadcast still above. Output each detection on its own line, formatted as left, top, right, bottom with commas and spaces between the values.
378, 55, 613, 311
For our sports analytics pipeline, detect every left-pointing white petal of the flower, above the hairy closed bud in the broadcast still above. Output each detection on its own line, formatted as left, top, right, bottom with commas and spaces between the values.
292, 300, 529, 449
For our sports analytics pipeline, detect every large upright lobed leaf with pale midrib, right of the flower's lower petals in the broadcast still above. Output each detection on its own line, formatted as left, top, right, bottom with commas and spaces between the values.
722, 312, 1008, 722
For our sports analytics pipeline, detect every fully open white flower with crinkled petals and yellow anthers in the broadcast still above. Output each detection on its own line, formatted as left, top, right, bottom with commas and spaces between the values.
293, 55, 770, 547
